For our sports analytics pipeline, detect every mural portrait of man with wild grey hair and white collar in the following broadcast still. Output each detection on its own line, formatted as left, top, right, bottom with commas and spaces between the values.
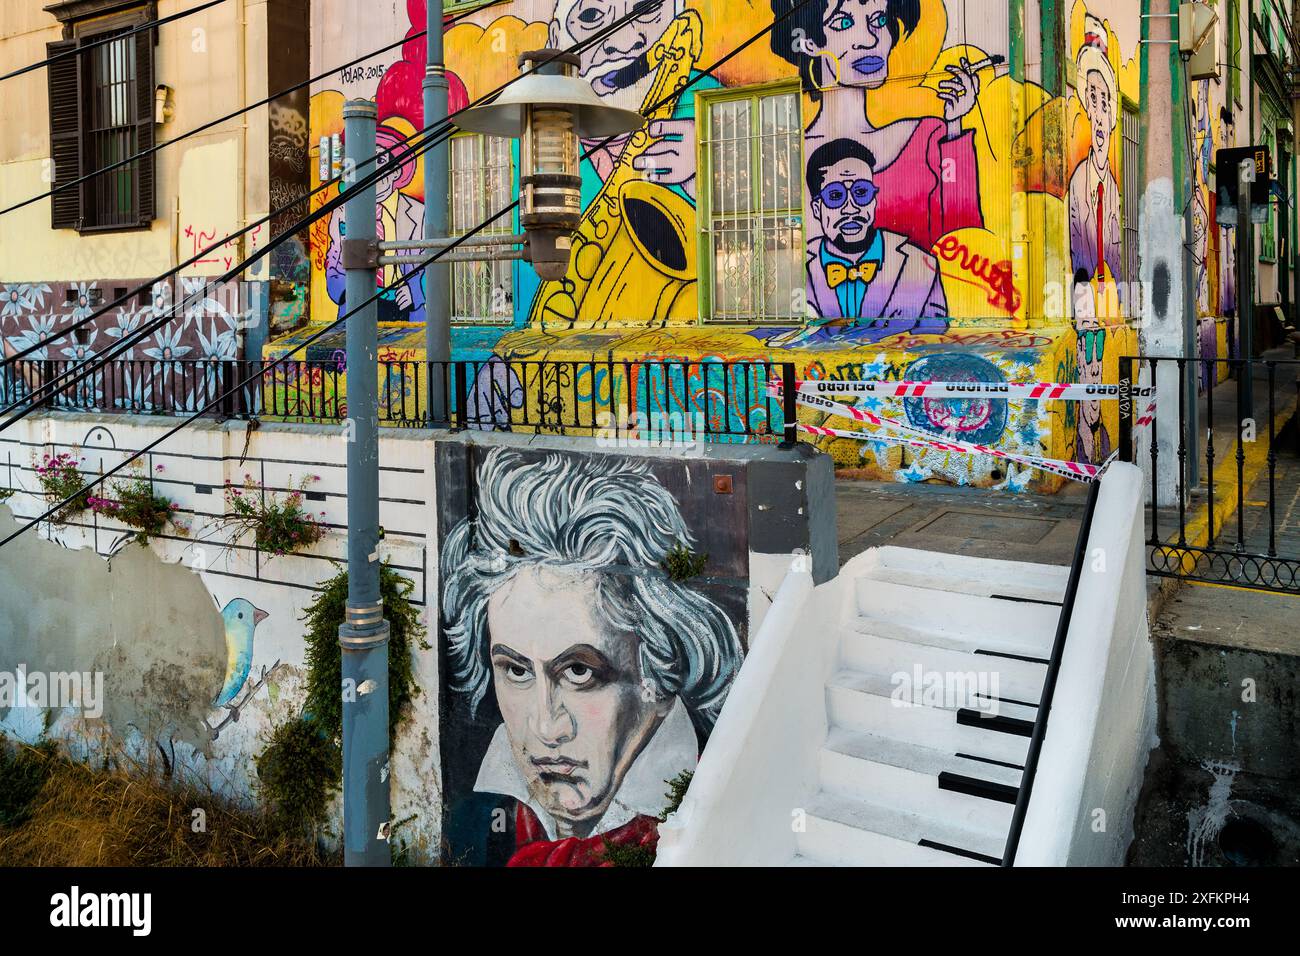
441, 449, 742, 866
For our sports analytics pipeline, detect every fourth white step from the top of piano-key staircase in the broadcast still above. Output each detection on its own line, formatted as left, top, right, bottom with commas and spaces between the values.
826, 669, 1036, 766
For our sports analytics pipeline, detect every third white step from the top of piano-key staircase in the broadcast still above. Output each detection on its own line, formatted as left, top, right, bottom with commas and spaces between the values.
840, 627, 1047, 704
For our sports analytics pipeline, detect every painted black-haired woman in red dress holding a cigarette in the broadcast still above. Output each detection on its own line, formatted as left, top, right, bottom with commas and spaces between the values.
771, 0, 984, 250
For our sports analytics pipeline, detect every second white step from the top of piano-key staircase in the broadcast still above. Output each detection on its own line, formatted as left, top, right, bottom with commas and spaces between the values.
854, 578, 1061, 657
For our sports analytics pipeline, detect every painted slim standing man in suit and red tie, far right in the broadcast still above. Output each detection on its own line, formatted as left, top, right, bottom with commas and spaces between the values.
1070, 16, 1123, 281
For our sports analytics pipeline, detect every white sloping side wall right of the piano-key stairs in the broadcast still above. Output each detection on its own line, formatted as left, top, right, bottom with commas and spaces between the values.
1015, 463, 1157, 866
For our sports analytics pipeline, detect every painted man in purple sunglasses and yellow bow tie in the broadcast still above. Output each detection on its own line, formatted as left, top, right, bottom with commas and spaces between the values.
807, 139, 948, 332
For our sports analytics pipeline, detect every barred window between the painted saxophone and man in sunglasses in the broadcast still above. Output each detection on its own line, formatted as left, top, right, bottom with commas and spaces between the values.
697, 86, 806, 323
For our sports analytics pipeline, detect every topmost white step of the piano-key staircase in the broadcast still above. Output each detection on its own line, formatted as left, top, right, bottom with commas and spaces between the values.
858, 545, 1070, 602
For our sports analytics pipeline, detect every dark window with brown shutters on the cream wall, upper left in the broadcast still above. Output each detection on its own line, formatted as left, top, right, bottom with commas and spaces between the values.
47, 4, 157, 232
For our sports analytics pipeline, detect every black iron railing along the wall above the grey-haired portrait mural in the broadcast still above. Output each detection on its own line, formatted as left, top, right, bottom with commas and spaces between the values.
0, 352, 796, 442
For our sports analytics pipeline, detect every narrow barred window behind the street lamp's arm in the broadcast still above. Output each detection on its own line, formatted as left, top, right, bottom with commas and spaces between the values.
450, 133, 515, 324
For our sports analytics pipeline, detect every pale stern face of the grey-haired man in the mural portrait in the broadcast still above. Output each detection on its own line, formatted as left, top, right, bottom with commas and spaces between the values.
488, 567, 673, 836
